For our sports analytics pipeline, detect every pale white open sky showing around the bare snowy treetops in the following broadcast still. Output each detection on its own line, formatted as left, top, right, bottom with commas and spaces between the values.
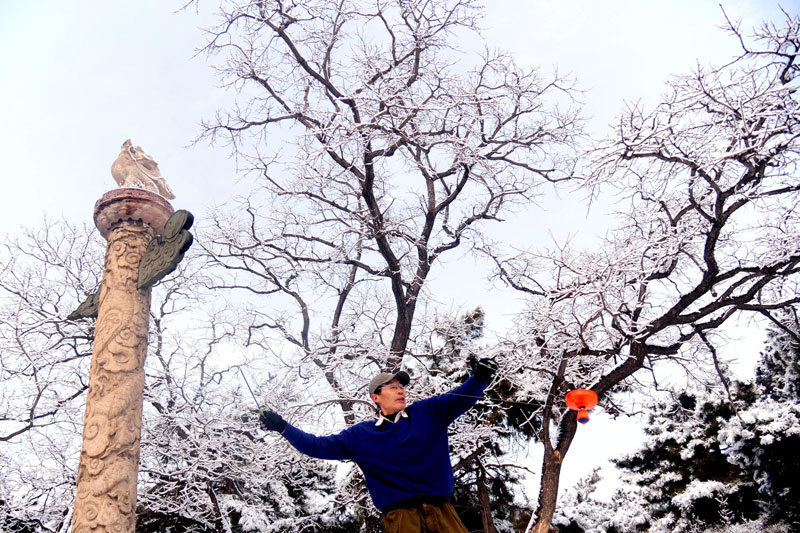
0, 0, 796, 502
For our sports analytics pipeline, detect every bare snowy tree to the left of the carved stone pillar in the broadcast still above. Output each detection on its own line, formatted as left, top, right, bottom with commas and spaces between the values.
0, 220, 103, 531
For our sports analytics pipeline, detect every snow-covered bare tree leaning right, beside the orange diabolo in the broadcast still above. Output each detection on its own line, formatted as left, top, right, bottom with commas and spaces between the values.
485, 15, 800, 533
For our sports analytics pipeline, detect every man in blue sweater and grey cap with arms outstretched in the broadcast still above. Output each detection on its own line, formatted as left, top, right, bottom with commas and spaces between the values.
261, 359, 497, 533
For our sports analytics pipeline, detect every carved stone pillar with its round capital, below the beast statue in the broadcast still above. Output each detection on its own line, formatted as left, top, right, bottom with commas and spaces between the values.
72, 188, 172, 533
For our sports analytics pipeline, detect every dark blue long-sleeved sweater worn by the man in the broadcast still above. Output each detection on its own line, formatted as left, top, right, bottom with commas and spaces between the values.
283, 377, 486, 510
